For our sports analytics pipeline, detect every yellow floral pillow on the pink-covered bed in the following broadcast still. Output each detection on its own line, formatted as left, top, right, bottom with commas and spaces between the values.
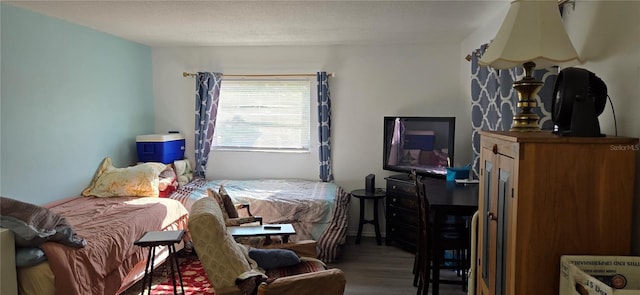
82, 157, 166, 198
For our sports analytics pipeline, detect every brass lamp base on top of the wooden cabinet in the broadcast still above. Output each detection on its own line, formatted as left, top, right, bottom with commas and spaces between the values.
510, 62, 543, 132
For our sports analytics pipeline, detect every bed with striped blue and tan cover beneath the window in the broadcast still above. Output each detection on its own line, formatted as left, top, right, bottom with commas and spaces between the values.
169, 179, 350, 262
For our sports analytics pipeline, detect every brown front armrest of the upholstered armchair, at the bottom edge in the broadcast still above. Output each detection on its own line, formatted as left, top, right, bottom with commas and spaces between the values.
258, 268, 347, 295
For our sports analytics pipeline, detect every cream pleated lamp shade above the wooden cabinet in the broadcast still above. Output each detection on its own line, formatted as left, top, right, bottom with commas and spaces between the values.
479, 0, 579, 69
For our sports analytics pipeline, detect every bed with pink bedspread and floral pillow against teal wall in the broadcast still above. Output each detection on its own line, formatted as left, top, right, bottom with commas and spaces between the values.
5, 157, 188, 295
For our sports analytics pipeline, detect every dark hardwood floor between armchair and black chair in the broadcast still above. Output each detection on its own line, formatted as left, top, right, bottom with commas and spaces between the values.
329, 237, 467, 295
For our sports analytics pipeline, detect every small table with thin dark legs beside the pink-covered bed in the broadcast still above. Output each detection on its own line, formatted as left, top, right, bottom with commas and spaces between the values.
133, 230, 184, 294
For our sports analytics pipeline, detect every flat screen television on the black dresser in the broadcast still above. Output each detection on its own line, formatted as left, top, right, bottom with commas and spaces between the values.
382, 117, 456, 177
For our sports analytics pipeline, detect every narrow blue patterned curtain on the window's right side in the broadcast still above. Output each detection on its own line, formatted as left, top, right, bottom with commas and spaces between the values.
316, 72, 333, 182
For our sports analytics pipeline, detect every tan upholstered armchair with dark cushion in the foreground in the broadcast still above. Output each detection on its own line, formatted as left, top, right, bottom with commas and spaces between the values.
188, 198, 346, 295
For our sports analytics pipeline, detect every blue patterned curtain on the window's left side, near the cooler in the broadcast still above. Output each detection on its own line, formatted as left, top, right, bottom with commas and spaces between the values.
193, 72, 222, 178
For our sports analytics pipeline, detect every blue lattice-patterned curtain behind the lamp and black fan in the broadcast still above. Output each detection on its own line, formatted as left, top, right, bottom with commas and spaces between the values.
471, 44, 558, 175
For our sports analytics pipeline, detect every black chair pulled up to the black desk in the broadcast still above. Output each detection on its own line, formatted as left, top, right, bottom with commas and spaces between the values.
412, 172, 470, 295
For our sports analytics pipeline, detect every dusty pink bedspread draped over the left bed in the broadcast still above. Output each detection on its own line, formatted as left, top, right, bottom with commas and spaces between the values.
42, 197, 188, 295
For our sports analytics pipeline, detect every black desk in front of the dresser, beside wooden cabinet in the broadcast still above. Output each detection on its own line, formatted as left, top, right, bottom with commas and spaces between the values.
422, 177, 478, 295
